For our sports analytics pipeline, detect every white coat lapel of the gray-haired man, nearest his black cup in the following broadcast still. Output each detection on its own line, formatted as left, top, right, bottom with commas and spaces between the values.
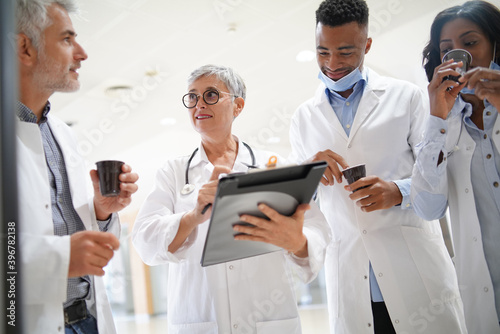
49, 116, 97, 230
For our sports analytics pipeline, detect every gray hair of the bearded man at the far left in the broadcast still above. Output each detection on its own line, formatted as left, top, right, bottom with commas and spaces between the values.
16, 0, 78, 49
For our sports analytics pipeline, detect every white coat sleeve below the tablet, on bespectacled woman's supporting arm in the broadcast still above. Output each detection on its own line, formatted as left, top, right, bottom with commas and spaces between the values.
287, 201, 331, 283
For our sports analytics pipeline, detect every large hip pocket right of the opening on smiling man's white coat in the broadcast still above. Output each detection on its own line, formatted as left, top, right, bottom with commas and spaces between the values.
401, 226, 459, 303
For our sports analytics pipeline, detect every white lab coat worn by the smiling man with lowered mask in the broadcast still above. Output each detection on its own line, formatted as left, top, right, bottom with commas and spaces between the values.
290, 69, 465, 334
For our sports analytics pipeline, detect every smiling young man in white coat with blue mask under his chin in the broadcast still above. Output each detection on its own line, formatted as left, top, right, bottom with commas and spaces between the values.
290, 0, 465, 334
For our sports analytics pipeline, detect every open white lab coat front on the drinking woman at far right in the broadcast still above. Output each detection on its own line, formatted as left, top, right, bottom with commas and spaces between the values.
412, 100, 500, 334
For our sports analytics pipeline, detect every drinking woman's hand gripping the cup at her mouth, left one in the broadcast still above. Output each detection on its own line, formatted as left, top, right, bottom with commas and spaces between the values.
427, 59, 465, 119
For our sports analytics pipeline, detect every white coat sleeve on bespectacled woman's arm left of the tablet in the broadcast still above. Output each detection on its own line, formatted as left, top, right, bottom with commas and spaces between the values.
132, 165, 197, 265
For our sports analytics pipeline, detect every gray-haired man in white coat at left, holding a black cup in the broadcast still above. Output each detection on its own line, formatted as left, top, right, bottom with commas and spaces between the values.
16, 0, 138, 334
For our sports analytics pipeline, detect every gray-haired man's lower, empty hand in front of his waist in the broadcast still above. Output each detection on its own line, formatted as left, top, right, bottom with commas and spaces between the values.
68, 231, 120, 277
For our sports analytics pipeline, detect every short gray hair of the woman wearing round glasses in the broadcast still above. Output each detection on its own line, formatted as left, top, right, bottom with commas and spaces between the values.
188, 65, 247, 99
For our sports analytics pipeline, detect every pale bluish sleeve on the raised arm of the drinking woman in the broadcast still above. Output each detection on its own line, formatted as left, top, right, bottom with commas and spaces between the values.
411, 116, 454, 220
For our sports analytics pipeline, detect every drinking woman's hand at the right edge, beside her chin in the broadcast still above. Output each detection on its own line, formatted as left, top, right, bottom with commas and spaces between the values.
464, 67, 500, 112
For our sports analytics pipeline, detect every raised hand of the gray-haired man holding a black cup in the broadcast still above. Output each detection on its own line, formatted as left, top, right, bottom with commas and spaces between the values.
90, 164, 139, 220
